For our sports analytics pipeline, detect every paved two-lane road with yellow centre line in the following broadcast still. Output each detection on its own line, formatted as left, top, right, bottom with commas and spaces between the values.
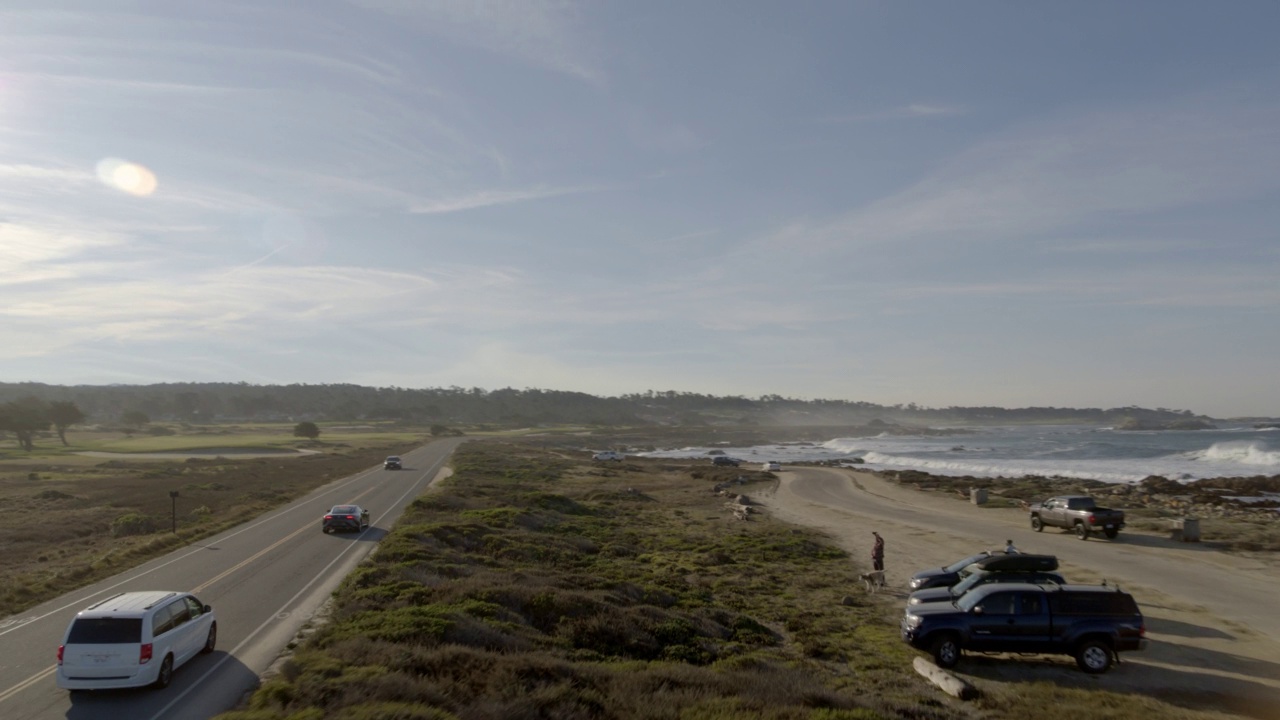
0, 439, 462, 720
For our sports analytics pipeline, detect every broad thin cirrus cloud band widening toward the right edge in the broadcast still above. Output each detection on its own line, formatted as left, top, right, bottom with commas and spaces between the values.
776, 94, 1280, 251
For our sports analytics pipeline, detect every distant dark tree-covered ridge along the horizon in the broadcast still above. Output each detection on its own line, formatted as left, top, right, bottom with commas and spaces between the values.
0, 383, 1208, 427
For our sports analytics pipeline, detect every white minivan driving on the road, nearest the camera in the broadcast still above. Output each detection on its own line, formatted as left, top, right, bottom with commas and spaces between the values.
58, 591, 218, 691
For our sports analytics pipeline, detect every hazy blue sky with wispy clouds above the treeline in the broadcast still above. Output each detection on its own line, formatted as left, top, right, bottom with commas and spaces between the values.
0, 0, 1280, 418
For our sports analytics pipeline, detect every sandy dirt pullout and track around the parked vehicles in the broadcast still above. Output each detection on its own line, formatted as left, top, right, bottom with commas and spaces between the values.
756, 468, 1280, 719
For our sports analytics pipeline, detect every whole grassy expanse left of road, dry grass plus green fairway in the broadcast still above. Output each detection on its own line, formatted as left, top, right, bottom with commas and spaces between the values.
0, 425, 424, 616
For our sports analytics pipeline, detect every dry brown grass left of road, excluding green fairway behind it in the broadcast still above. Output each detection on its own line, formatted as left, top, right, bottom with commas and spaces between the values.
0, 427, 417, 616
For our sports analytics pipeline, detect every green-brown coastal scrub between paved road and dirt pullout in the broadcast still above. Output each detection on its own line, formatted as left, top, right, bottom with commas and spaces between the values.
209, 441, 1229, 720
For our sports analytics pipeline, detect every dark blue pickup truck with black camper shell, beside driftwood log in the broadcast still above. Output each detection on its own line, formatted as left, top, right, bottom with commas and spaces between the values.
901, 583, 1147, 674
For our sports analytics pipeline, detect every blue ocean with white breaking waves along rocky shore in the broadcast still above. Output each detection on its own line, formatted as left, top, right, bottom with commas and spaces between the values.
640, 425, 1280, 483
